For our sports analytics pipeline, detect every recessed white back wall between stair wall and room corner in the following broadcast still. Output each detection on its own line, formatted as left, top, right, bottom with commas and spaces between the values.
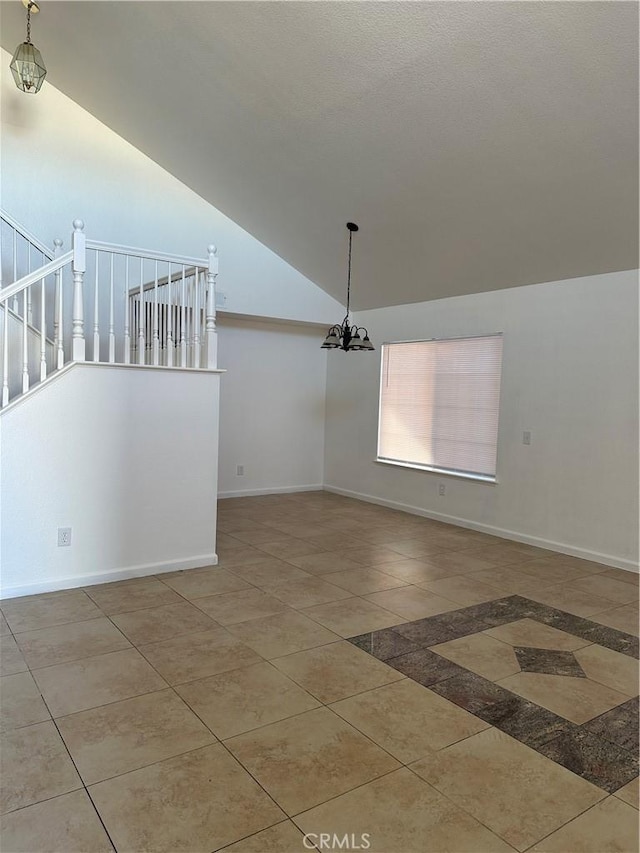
218, 318, 327, 497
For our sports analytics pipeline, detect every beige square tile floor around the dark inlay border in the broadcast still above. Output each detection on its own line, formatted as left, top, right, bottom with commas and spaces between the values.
0, 492, 638, 853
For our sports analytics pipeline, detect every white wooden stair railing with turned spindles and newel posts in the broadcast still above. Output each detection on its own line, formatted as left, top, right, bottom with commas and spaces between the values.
0, 211, 218, 409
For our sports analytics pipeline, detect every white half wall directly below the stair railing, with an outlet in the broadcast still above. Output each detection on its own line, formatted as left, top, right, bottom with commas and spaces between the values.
0, 364, 220, 597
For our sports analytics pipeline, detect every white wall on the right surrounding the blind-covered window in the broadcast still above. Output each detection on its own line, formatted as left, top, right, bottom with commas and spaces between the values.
325, 272, 638, 569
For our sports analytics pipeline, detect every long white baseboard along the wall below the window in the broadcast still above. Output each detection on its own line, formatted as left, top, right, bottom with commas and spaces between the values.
323, 485, 640, 573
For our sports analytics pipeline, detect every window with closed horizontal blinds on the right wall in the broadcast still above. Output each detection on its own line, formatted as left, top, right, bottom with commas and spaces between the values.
378, 334, 502, 482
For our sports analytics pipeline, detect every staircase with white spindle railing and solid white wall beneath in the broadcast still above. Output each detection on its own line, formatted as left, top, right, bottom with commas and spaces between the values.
0, 211, 224, 598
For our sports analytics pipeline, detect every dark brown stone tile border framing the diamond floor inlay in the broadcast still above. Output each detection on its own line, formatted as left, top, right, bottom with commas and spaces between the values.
349, 595, 638, 793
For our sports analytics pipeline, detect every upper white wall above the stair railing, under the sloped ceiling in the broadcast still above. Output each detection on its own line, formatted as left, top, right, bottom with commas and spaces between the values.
0, 51, 342, 325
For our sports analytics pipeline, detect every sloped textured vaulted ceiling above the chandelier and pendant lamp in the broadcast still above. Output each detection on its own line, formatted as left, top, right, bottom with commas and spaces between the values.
0, 0, 638, 308
